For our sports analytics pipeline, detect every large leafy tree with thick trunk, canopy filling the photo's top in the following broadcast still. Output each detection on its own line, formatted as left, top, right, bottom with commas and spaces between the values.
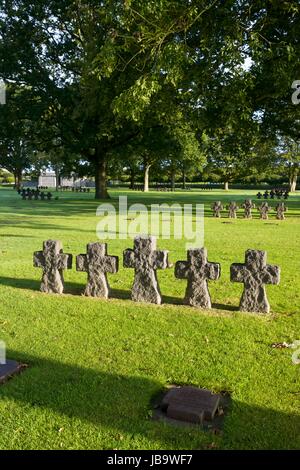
0, 0, 300, 198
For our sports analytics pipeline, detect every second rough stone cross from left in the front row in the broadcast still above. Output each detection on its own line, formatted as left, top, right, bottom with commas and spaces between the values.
76, 243, 119, 299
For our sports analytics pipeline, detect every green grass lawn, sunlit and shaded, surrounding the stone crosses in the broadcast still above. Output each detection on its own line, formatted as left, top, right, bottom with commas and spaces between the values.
0, 185, 300, 449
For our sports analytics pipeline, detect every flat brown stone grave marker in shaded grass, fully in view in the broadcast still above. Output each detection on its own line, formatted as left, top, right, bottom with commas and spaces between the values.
160, 386, 221, 424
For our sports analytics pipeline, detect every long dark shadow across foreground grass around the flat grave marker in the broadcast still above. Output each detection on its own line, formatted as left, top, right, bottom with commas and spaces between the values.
0, 350, 300, 449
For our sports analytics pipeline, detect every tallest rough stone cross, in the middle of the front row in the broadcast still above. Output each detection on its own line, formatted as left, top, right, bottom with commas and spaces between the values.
123, 236, 169, 304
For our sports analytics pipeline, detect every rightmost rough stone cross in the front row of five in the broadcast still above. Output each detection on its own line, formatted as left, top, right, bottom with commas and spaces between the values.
230, 250, 280, 313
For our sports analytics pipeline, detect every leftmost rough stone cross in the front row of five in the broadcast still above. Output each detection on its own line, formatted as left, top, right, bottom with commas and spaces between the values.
33, 240, 72, 294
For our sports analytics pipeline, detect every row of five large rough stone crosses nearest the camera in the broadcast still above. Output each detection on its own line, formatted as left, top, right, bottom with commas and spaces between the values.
34, 236, 280, 313
